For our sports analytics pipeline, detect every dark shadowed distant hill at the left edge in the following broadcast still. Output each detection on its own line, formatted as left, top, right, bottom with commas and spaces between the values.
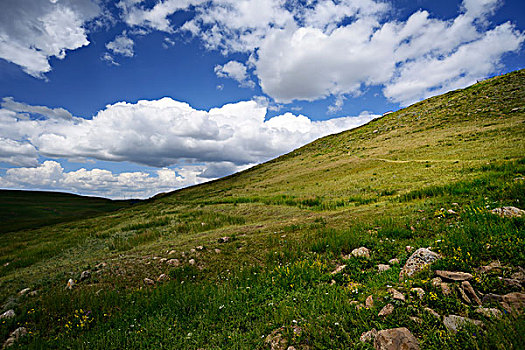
0, 190, 136, 234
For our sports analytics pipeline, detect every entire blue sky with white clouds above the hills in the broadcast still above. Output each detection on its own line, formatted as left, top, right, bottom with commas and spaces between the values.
0, 0, 525, 199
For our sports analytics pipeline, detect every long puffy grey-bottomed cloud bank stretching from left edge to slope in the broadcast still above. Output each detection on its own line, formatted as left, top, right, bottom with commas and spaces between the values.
0, 98, 373, 167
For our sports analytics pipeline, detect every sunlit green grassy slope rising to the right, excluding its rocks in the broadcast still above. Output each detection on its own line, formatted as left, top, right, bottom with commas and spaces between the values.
0, 70, 525, 349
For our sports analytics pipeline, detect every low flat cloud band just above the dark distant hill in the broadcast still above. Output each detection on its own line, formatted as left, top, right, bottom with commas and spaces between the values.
0, 160, 207, 199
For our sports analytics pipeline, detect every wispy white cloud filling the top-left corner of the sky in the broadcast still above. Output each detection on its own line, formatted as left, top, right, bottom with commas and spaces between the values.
0, 0, 101, 78
